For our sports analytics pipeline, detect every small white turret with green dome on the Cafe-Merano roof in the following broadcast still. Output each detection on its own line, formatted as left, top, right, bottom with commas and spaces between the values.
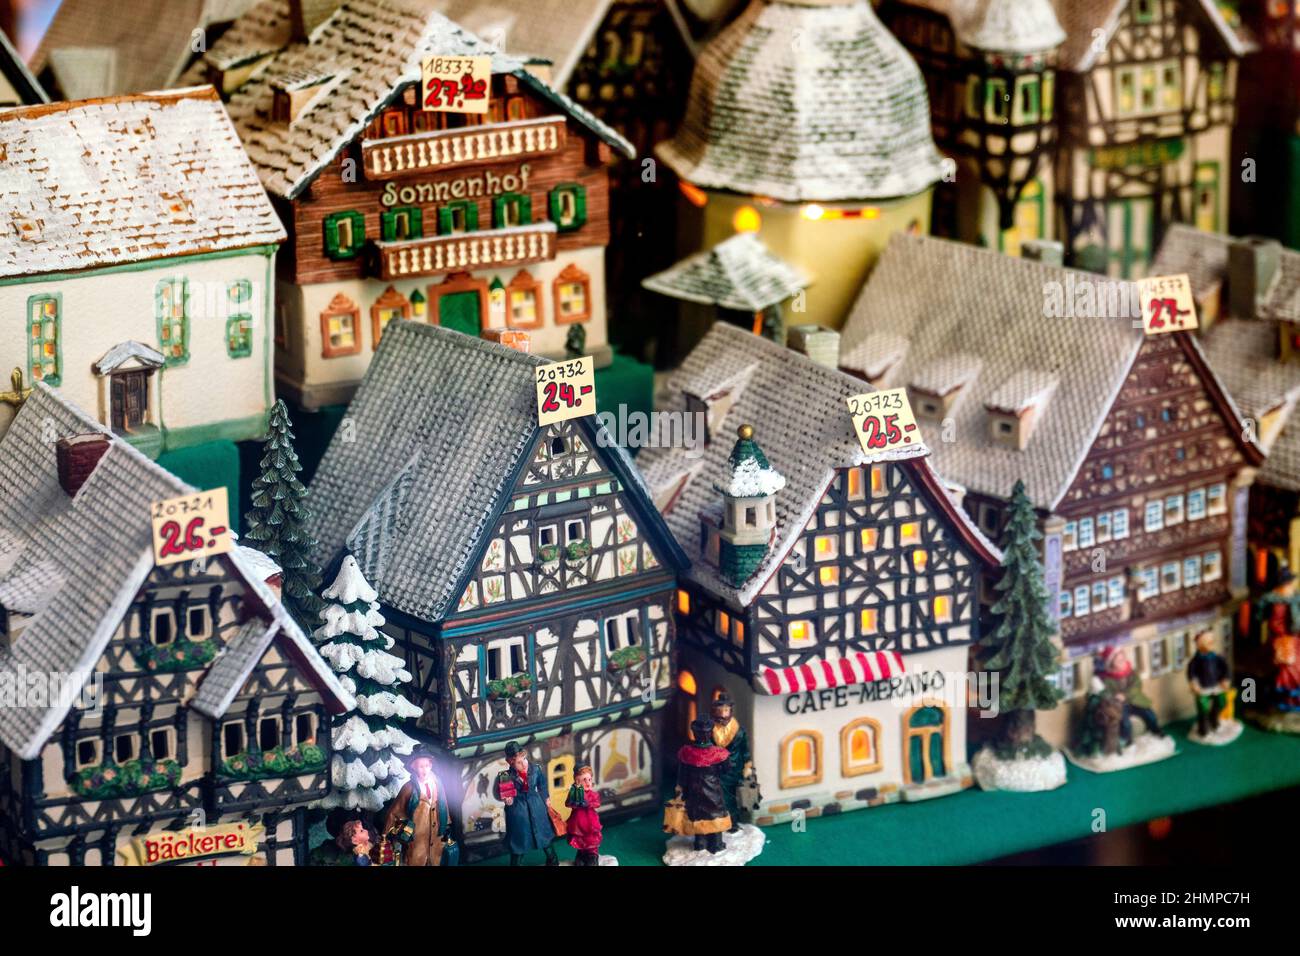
714, 425, 785, 588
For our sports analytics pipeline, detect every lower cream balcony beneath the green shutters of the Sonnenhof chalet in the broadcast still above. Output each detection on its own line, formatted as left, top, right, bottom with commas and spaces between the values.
374, 222, 555, 281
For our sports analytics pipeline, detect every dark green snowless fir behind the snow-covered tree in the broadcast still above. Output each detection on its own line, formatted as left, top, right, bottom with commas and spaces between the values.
243, 402, 321, 623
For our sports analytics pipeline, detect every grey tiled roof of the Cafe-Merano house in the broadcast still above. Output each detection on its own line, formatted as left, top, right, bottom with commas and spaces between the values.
637, 323, 997, 606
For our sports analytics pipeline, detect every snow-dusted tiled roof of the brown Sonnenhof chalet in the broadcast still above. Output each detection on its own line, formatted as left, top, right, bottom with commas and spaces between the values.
187, 0, 634, 199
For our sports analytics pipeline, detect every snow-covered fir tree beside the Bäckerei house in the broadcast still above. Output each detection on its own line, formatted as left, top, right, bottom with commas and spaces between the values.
316, 554, 423, 810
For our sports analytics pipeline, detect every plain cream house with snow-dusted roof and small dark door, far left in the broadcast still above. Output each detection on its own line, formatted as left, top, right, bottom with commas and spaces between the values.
0, 87, 285, 457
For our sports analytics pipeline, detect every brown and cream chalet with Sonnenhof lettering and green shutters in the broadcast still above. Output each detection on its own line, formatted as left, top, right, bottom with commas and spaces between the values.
195, 0, 632, 408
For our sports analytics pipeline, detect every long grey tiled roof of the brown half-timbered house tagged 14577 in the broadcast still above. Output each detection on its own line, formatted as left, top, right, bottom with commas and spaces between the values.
840, 234, 1143, 509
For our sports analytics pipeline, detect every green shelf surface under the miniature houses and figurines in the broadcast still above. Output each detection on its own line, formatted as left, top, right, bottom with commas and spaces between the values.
473, 723, 1300, 866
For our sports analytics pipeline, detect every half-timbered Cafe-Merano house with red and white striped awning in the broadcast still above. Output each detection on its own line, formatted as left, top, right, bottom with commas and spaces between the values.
638, 323, 1001, 825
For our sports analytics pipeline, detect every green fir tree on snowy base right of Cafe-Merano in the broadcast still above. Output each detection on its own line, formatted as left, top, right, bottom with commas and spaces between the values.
980, 481, 1061, 760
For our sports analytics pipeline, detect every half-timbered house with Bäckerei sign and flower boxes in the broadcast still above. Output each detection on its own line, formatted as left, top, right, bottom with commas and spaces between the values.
0, 384, 354, 866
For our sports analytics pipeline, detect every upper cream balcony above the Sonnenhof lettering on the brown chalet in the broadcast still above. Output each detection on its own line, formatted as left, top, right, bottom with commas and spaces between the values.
361, 116, 566, 179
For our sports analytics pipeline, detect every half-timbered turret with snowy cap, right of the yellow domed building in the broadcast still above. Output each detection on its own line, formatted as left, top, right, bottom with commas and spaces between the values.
880, 0, 1065, 255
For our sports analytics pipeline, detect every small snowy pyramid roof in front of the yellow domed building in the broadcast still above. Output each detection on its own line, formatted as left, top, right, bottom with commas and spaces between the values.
641, 233, 809, 312
